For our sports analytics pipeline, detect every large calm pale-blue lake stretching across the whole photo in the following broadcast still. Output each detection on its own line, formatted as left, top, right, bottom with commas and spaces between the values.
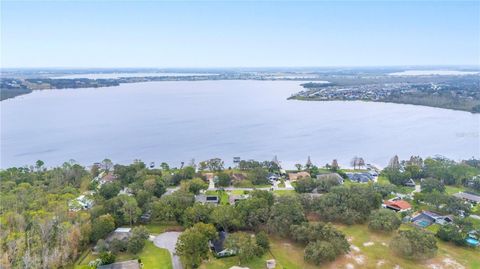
0, 80, 480, 168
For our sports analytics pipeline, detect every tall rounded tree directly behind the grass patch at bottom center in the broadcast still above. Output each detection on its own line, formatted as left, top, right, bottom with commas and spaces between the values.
268, 196, 305, 236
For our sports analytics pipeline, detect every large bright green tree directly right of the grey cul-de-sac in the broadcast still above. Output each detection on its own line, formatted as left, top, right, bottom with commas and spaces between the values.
175, 223, 218, 268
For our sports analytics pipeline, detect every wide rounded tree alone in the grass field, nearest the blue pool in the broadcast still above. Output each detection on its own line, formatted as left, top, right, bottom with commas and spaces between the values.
390, 229, 438, 260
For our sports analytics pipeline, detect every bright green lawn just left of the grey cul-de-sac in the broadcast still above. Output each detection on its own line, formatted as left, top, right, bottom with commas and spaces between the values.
73, 241, 172, 269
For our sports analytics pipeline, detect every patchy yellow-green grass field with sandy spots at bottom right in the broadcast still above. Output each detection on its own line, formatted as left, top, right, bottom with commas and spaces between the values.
200, 225, 480, 269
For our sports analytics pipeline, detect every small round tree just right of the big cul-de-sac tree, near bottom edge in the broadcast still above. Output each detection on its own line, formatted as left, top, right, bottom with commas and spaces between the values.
225, 232, 260, 264
